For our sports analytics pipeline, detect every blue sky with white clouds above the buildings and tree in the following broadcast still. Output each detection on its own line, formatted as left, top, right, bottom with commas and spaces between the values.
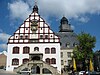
0, 0, 100, 51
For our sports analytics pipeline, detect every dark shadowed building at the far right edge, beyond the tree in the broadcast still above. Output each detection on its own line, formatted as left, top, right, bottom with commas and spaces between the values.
94, 50, 100, 72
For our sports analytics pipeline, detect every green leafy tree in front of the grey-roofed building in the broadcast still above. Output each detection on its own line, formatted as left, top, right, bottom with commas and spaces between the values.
73, 32, 96, 70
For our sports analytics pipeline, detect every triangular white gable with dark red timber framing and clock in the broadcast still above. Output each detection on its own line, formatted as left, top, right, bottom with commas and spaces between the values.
8, 11, 59, 43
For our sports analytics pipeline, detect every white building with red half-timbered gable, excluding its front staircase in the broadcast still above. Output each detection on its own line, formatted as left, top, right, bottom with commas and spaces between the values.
6, 5, 61, 73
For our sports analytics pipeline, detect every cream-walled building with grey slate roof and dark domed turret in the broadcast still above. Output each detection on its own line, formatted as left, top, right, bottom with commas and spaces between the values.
56, 17, 78, 68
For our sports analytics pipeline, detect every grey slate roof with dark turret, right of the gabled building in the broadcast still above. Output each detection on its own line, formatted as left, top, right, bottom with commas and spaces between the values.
56, 17, 78, 49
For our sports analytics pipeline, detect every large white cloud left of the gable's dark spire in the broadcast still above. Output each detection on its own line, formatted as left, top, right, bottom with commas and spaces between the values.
8, 0, 31, 20
